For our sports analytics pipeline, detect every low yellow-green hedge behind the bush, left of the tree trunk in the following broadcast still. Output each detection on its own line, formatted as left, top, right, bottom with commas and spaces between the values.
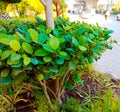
0, 17, 37, 34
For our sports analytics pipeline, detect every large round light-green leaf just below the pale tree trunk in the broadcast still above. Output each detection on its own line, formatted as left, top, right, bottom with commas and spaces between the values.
49, 36, 60, 50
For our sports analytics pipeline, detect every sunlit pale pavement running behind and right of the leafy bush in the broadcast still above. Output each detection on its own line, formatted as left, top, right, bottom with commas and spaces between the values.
70, 15, 120, 79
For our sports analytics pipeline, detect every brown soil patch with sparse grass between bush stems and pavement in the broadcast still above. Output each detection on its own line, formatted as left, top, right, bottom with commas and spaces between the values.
65, 74, 120, 102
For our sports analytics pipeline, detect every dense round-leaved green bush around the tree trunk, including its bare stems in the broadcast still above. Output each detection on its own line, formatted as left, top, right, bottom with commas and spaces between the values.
0, 17, 113, 108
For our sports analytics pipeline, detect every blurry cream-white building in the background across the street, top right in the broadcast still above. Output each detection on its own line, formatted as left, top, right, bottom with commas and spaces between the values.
66, 0, 120, 12
